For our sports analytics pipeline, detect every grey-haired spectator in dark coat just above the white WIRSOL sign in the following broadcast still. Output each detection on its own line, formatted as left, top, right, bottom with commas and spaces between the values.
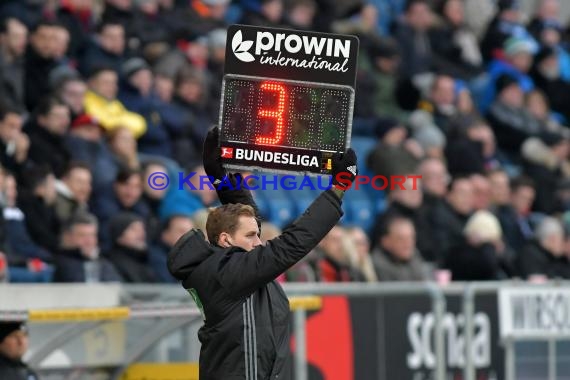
516, 216, 570, 279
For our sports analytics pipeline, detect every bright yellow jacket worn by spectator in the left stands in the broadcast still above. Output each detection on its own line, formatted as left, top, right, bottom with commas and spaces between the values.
84, 91, 146, 138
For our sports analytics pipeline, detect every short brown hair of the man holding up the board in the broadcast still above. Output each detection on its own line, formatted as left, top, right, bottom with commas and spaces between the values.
206, 203, 255, 244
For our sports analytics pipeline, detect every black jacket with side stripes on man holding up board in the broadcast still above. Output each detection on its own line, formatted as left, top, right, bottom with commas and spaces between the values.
168, 183, 343, 380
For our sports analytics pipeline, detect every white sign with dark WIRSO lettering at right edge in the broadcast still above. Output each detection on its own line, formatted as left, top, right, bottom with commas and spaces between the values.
499, 287, 570, 339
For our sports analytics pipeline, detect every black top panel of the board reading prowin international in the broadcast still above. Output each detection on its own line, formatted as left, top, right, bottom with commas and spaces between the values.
225, 25, 359, 88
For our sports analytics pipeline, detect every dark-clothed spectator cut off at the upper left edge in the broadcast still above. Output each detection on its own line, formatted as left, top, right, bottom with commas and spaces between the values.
0, 17, 28, 109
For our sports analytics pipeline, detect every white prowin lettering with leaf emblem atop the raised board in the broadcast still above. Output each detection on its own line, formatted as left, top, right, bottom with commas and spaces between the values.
232, 30, 351, 73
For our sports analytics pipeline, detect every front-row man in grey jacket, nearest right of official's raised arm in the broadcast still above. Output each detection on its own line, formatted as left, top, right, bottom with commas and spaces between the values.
372, 216, 431, 281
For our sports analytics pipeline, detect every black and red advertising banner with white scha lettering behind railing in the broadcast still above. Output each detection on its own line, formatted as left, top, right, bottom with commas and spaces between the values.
293, 295, 504, 380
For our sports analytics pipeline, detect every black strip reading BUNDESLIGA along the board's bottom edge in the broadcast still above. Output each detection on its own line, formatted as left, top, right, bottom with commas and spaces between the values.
217, 142, 333, 175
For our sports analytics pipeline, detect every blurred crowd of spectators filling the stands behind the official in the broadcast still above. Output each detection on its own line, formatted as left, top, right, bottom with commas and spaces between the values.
0, 0, 570, 283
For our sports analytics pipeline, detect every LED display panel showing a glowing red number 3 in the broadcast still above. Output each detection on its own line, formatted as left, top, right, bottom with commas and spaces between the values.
220, 75, 354, 152
